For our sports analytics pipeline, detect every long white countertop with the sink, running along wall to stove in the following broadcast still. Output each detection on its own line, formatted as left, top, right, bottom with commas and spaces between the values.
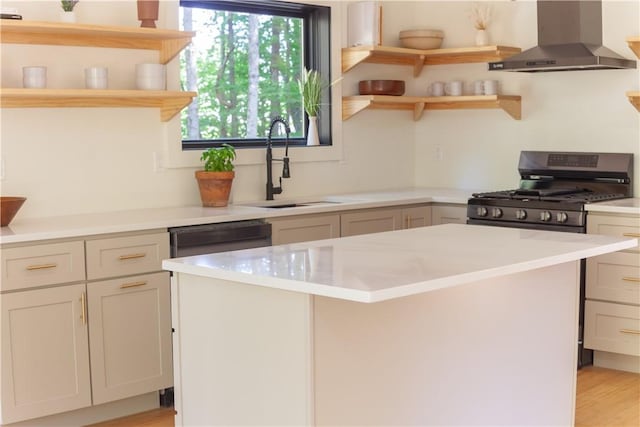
0, 188, 474, 244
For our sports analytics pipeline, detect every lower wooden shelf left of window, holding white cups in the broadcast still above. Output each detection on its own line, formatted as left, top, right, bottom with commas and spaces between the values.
0, 88, 197, 122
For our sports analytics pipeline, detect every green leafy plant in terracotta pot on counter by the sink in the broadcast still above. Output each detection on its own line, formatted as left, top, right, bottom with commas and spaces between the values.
196, 144, 236, 207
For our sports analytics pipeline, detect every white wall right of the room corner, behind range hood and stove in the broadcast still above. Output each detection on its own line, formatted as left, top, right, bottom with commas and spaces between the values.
385, 0, 640, 191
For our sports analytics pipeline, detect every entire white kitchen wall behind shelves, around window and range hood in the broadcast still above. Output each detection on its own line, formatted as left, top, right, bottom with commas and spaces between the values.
0, 0, 640, 221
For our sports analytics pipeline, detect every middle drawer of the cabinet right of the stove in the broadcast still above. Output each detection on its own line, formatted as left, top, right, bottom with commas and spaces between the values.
586, 252, 640, 305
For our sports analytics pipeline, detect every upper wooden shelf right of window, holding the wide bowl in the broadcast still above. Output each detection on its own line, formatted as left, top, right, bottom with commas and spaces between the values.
342, 46, 520, 77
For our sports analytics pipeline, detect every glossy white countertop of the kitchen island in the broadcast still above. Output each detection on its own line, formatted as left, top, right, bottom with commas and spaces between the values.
163, 224, 637, 302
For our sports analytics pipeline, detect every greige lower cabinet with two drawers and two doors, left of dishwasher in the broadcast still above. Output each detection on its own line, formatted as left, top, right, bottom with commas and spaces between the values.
0, 230, 173, 425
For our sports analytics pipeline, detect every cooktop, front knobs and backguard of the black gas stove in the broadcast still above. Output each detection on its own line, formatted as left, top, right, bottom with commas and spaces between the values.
467, 151, 633, 233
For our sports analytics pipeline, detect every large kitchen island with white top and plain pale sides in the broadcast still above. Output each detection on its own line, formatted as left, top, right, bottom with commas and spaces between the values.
163, 224, 637, 426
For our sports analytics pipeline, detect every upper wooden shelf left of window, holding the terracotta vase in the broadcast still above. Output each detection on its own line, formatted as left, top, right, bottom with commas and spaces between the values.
0, 19, 195, 64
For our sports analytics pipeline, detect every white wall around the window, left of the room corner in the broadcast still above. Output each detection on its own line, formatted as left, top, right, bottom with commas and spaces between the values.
0, 0, 414, 218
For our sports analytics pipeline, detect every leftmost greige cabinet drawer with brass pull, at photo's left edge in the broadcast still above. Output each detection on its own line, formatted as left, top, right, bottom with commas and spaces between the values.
0, 241, 85, 291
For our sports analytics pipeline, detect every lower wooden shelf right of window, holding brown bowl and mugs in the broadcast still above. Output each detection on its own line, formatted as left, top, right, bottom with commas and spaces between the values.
342, 95, 522, 120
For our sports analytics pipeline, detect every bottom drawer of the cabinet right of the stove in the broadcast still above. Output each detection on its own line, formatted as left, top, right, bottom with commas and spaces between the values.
584, 301, 640, 356
